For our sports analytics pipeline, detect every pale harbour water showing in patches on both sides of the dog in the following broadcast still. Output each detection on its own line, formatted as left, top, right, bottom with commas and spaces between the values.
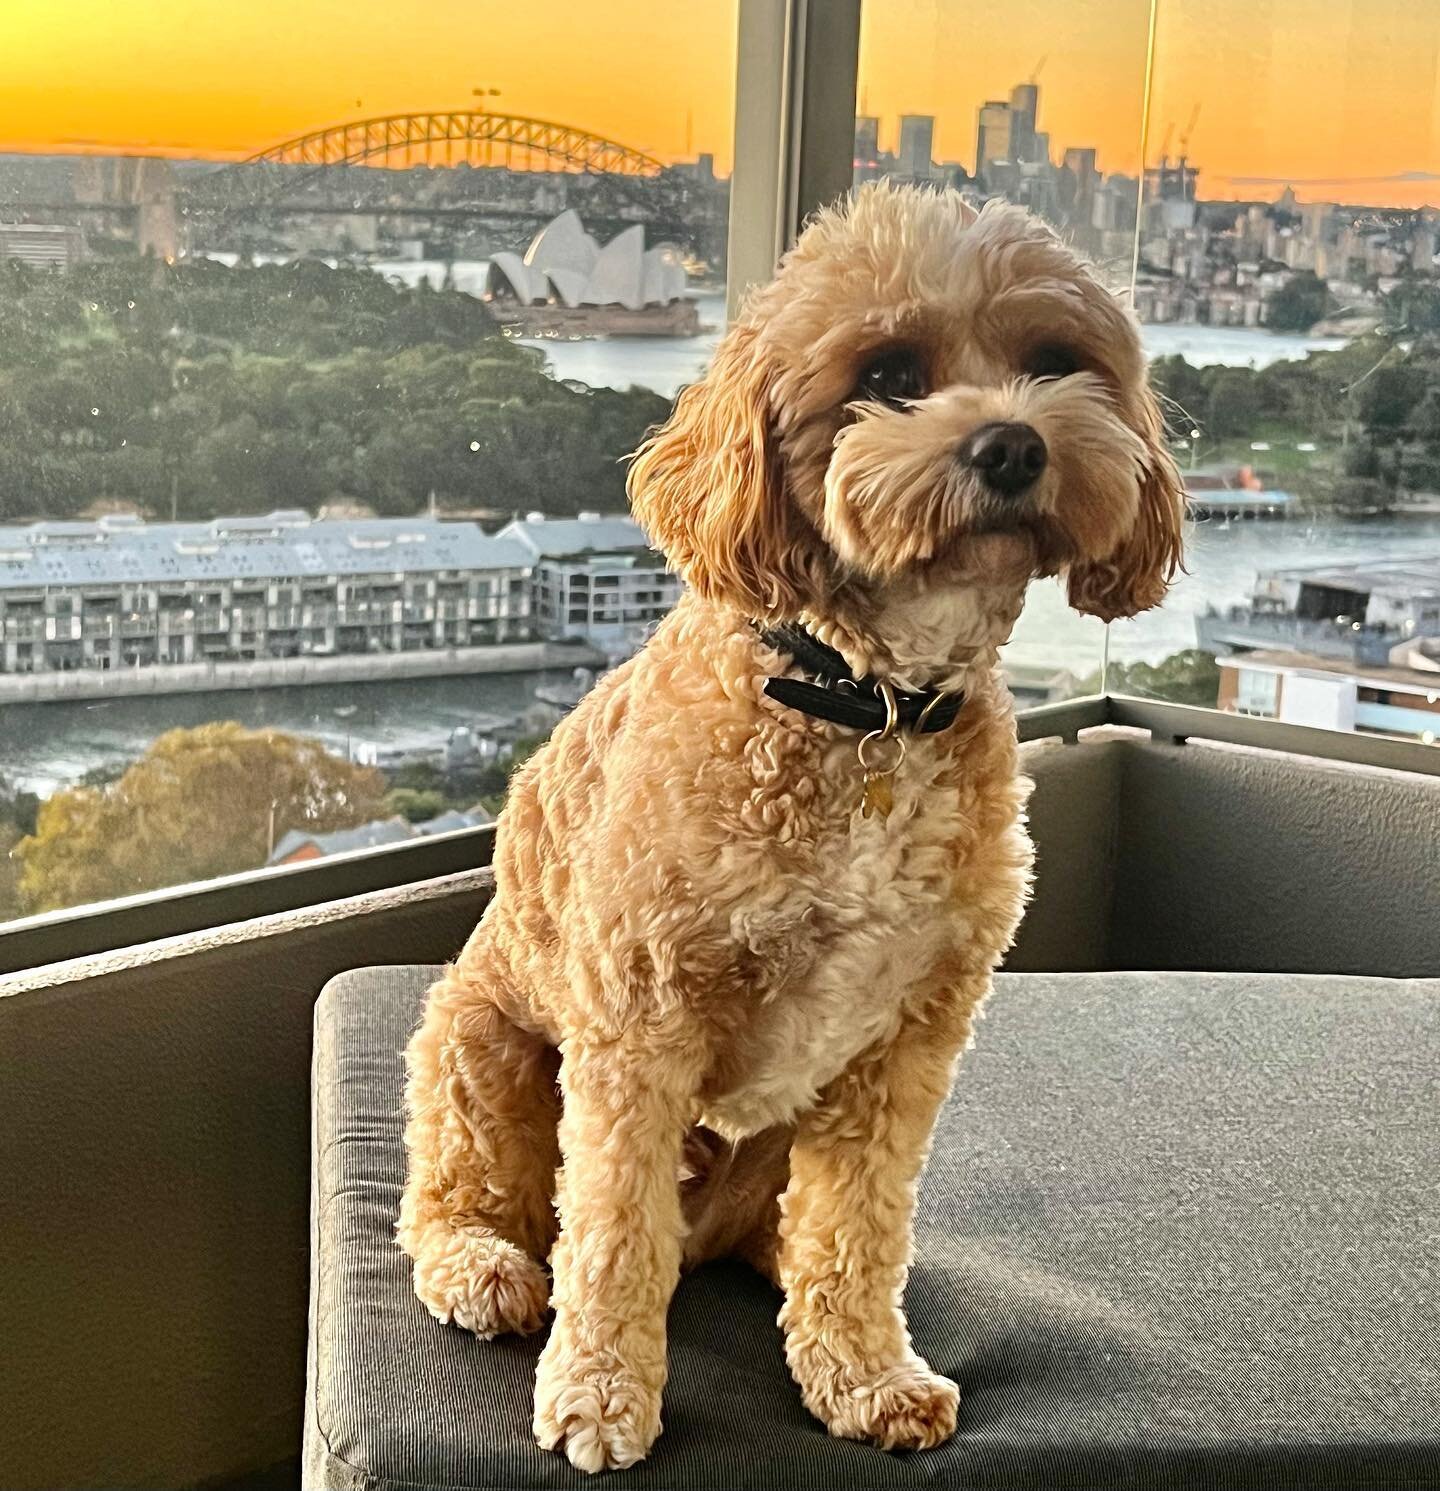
0, 287, 1440, 793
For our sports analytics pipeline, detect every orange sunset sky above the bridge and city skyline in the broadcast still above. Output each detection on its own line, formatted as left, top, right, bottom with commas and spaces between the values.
0, 0, 1440, 206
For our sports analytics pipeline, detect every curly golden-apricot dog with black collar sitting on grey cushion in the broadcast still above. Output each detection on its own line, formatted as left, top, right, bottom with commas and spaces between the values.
398, 183, 1182, 1472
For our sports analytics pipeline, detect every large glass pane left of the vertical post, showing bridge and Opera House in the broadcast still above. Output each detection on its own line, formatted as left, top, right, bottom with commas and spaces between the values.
0, 0, 736, 920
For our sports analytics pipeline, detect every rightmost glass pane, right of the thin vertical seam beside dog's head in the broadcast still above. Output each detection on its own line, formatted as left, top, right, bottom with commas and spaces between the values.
1109, 0, 1440, 741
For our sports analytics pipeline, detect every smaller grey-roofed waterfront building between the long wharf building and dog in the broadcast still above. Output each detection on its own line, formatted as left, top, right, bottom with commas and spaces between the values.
495, 513, 681, 658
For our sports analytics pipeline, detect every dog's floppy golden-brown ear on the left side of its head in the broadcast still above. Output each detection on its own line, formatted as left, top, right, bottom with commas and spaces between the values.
628, 325, 811, 619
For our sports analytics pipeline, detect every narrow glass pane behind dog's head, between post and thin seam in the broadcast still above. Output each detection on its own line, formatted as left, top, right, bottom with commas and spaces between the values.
854, 0, 1149, 705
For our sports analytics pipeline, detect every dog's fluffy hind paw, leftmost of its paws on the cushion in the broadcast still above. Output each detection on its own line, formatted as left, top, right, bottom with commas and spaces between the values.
414, 1227, 550, 1340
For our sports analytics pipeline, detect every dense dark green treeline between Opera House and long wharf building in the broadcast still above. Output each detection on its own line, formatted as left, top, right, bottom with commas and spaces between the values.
0, 259, 669, 520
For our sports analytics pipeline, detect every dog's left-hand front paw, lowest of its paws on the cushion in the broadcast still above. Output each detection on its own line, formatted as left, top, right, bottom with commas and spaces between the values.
535, 1330, 665, 1472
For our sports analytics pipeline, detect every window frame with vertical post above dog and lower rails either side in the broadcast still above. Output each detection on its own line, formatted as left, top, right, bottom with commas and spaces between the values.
0, 0, 1440, 977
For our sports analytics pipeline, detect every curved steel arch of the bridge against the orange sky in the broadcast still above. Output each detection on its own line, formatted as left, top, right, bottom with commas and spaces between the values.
241, 109, 665, 176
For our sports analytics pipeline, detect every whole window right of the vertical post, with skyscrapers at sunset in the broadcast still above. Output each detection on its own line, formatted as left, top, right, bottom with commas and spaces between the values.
854, 0, 1440, 728
